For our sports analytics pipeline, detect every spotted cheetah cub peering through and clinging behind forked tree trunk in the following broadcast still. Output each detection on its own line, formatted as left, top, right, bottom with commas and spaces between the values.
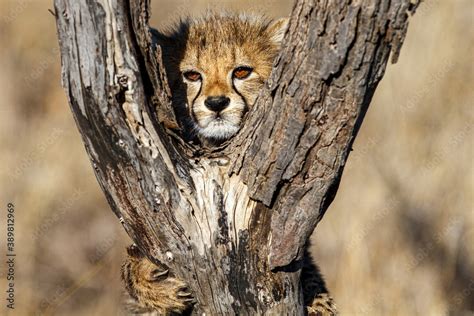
122, 13, 336, 316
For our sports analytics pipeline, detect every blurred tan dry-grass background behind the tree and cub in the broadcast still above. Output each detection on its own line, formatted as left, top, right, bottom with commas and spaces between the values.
0, 0, 474, 315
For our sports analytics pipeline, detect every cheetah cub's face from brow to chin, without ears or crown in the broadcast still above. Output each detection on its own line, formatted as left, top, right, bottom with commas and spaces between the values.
180, 47, 272, 140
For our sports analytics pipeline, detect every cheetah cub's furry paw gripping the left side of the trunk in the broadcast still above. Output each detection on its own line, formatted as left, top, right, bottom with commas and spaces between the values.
122, 246, 196, 315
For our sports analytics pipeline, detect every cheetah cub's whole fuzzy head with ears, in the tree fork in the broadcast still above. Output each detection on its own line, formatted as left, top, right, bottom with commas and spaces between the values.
158, 14, 287, 143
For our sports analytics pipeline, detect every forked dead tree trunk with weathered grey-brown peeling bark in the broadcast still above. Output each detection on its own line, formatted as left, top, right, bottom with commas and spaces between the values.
55, 0, 417, 315
